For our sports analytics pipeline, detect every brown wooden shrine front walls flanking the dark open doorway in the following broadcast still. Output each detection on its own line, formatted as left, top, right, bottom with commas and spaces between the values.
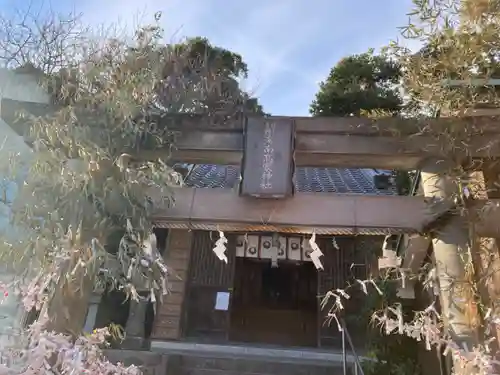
152, 230, 382, 347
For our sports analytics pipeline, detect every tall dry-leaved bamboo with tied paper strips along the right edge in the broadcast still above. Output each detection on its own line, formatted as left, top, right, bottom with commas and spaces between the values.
362, 0, 500, 375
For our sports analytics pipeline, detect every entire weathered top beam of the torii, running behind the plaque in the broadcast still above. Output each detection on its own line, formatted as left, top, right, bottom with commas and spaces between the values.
5, 99, 500, 169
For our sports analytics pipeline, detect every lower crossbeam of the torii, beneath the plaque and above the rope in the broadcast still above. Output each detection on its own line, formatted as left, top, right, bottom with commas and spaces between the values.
152, 188, 500, 237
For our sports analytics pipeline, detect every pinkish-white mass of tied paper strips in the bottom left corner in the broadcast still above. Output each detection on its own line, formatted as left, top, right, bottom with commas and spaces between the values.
0, 276, 142, 375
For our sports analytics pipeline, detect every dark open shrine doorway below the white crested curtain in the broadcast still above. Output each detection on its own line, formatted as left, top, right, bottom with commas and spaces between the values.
230, 258, 318, 347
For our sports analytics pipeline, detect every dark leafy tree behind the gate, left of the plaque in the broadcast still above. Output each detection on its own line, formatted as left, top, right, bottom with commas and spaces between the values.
45, 36, 262, 115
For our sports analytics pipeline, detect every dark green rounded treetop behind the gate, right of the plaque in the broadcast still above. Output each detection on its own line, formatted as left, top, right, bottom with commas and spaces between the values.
310, 50, 402, 116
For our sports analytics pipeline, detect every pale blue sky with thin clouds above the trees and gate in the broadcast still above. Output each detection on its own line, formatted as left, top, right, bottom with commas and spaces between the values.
0, 0, 418, 116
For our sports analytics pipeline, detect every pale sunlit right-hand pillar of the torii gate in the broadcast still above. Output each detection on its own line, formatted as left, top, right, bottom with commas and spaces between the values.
422, 161, 479, 368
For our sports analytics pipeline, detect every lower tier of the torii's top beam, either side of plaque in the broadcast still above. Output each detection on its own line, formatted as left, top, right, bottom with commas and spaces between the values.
166, 130, 500, 169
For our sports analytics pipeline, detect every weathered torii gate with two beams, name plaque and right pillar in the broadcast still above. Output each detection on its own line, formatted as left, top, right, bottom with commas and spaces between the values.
1, 100, 500, 356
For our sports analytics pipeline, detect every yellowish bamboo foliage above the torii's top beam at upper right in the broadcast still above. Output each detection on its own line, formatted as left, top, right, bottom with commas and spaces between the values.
390, 0, 500, 116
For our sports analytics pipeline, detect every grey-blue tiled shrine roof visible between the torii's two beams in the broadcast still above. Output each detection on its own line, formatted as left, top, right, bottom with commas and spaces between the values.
185, 164, 395, 195
